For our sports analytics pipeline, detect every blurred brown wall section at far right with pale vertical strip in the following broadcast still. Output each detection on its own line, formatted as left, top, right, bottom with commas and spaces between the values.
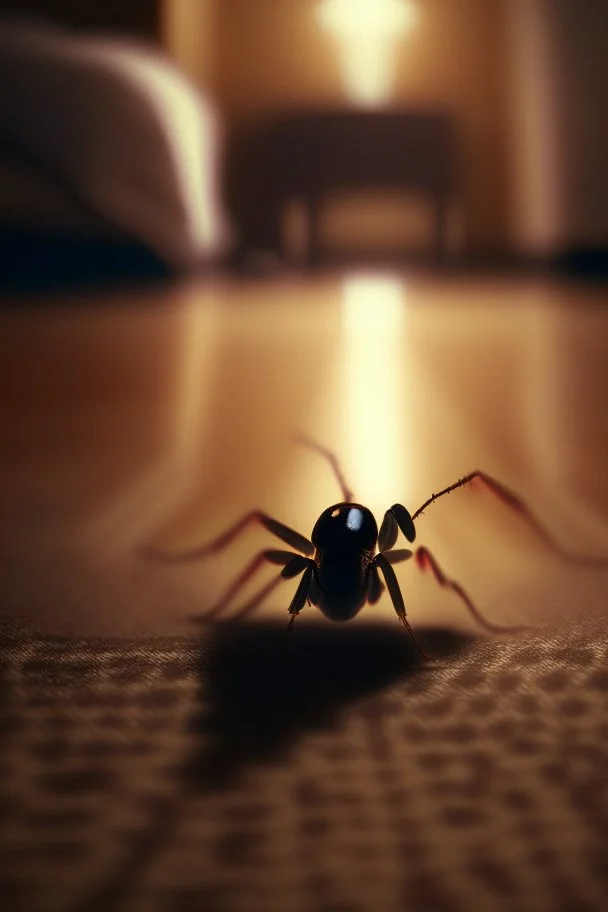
509, 0, 608, 252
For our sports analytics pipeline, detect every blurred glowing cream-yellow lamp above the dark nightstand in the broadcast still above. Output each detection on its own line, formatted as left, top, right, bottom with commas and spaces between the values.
317, 0, 418, 105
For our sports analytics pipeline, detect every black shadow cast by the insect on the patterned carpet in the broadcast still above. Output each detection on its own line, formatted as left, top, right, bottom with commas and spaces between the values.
187, 621, 471, 791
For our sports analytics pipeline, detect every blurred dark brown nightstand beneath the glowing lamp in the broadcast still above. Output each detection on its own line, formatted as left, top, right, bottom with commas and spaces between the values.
265, 110, 457, 263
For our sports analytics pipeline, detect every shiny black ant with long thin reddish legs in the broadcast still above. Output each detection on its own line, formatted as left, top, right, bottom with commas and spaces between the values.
146, 437, 605, 658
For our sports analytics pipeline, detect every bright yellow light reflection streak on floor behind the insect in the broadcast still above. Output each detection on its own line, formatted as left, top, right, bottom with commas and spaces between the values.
342, 274, 407, 511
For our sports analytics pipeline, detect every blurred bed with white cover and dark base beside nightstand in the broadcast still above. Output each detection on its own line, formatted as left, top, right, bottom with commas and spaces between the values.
0, 19, 230, 277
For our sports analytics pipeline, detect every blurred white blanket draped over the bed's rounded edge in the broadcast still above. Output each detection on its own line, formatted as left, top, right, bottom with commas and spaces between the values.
0, 22, 229, 269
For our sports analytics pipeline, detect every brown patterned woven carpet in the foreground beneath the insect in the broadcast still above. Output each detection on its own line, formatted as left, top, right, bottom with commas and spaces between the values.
0, 622, 608, 912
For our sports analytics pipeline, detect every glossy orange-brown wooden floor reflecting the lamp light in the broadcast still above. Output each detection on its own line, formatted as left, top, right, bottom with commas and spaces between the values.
0, 272, 608, 634
